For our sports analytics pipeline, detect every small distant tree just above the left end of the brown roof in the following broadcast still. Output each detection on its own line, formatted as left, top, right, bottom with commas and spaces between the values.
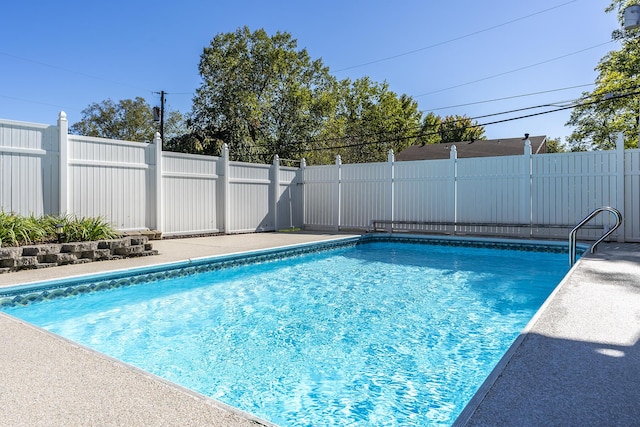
419, 112, 486, 145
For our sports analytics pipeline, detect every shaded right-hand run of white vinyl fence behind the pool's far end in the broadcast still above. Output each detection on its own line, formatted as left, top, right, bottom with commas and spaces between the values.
303, 137, 640, 241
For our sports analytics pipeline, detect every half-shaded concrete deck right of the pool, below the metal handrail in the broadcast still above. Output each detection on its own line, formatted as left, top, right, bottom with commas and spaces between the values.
455, 243, 640, 426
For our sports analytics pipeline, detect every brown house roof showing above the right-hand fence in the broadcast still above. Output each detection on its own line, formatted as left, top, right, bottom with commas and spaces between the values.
395, 135, 547, 161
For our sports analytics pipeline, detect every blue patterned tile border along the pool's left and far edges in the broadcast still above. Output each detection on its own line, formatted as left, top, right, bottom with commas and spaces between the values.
0, 234, 586, 309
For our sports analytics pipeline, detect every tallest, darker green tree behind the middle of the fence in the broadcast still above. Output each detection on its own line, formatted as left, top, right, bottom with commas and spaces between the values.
190, 27, 336, 162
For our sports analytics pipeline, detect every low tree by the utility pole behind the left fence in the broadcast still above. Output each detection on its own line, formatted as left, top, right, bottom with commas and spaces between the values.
70, 97, 183, 142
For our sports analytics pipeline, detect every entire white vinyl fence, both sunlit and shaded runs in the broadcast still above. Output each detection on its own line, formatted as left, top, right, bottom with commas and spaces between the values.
0, 113, 640, 242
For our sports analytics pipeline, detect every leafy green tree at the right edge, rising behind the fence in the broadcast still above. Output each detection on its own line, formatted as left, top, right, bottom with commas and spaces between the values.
567, 0, 640, 151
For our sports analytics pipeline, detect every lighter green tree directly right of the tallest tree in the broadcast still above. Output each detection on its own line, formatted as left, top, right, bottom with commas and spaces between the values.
305, 77, 421, 164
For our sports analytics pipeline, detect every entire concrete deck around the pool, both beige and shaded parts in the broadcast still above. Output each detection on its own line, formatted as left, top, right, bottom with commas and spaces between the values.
0, 233, 640, 426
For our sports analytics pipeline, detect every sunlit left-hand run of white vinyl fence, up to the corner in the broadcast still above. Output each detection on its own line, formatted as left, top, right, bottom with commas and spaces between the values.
0, 113, 302, 235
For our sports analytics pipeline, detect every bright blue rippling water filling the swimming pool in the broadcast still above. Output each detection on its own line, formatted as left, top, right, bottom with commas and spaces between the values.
4, 241, 568, 426
